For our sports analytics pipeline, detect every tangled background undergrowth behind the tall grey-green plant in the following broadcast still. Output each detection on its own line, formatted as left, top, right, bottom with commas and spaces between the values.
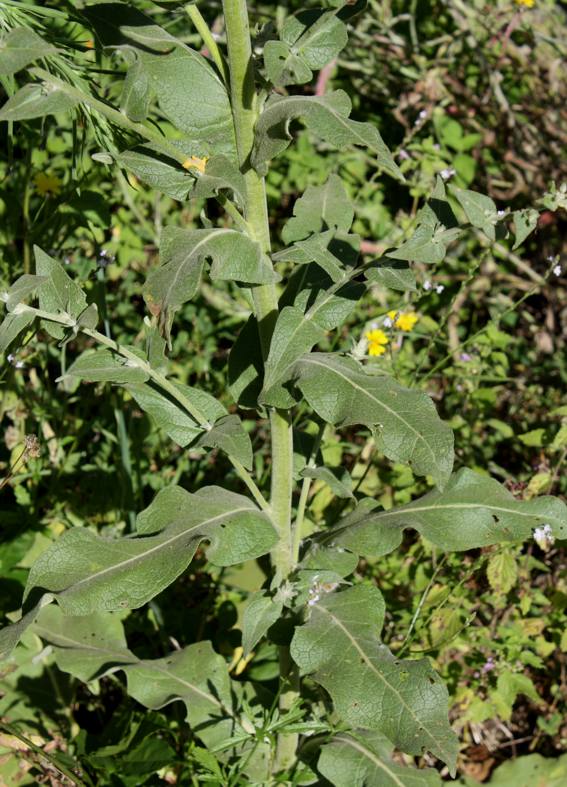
0, 0, 567, 785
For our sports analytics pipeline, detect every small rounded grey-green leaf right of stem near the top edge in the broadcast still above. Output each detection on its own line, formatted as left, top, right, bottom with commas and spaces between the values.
264, 10, 348, 86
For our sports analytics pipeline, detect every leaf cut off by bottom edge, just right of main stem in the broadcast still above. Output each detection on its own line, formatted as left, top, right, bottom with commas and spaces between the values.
317, 730, 442, 787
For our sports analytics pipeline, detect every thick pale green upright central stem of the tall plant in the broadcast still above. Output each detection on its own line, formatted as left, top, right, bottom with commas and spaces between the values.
223, 0, 297, 769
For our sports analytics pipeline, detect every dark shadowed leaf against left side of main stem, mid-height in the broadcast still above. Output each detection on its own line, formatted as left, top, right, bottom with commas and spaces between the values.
228, 315, 264, 409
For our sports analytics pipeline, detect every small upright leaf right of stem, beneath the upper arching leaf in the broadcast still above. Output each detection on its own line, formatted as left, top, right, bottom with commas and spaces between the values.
282, 175, 354, 244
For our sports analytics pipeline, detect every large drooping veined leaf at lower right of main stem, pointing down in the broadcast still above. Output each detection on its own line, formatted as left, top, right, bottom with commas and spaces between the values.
291, 585, 458, 772
